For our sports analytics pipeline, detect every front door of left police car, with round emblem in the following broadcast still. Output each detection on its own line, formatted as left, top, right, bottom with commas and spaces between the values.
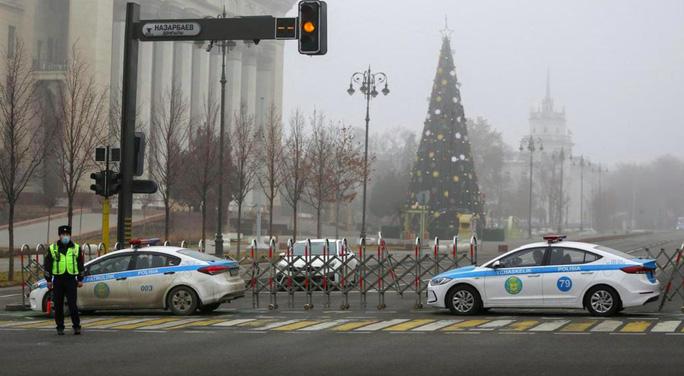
78, 252, 132, 309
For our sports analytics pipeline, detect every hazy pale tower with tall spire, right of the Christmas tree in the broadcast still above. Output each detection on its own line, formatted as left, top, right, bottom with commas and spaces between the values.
530, 70, 573, 154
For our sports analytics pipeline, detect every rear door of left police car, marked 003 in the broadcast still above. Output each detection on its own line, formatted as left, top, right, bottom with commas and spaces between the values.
129, 251, 181, 308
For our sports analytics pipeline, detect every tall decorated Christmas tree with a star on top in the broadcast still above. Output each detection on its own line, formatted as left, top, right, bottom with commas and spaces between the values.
407, 32, 482, 238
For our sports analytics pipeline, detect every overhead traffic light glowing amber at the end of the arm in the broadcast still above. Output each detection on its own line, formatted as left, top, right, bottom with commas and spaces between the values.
299, 0, 328, 55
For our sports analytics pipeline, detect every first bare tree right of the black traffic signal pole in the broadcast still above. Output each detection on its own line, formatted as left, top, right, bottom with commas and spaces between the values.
149, 84, 189, 240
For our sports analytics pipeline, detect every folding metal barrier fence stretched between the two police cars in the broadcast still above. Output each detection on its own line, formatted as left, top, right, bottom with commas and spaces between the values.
239, 238, 477, 310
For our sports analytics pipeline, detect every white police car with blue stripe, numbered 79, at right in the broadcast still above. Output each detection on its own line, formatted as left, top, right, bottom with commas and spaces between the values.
427, 235, 660, 316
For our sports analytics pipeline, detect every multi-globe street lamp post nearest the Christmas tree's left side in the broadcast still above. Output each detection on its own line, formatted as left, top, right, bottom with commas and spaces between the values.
347, 66, 389, 244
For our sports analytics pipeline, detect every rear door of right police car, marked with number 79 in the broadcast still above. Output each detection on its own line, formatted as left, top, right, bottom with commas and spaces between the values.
542, 246, 600, 307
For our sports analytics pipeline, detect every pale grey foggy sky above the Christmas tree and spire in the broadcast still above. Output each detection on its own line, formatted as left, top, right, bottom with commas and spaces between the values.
283, 0, 684, 163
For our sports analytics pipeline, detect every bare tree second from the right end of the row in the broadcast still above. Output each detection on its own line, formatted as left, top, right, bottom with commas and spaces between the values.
304, 110, 335, 238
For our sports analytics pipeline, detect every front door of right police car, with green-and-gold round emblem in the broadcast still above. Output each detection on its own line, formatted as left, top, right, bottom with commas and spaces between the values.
485, 247, 546, 307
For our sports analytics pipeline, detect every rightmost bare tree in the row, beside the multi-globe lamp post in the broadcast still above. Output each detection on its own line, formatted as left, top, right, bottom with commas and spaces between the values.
330, 124, 366, 238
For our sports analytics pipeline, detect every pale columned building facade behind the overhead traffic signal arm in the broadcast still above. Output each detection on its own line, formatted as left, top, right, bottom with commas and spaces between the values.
0, 0, 295, 198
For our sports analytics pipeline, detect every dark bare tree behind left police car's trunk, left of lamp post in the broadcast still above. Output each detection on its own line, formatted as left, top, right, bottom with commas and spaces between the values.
182, 103, 219, 251
